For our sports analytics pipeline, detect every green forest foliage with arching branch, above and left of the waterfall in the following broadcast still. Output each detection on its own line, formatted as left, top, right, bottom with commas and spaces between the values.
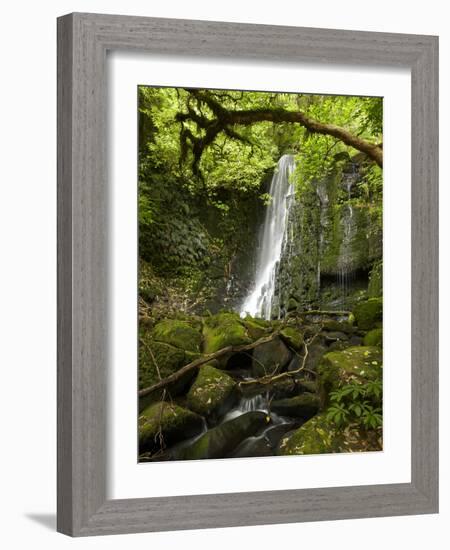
139, 86, 382, 316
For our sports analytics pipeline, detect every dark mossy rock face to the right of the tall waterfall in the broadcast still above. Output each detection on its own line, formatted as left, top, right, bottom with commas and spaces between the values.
274, 157, 382, 316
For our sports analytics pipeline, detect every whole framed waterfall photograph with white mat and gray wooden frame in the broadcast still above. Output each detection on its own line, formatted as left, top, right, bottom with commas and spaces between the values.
58, 14, 438, 536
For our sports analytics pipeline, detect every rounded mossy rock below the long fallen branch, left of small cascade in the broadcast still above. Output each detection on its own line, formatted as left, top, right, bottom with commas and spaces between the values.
187, 365, 236, 417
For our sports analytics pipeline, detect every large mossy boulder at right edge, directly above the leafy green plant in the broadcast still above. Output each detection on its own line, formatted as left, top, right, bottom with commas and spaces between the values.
317, 346, 383, 408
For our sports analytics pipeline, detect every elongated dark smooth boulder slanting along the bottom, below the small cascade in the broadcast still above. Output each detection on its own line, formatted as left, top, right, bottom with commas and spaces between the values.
182, 411, 270, 460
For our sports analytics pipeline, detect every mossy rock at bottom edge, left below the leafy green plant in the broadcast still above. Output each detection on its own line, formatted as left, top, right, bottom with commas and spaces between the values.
277, 413, 344, 455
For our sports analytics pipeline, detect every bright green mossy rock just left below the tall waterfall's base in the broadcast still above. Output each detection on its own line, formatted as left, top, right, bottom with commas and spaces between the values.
203, 313, 252, 354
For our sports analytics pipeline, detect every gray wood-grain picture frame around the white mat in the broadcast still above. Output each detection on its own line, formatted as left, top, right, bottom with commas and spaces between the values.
58, 13, 438, 536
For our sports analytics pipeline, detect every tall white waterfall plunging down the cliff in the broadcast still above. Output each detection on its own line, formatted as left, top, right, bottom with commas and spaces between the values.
240, 155, 295, 319
